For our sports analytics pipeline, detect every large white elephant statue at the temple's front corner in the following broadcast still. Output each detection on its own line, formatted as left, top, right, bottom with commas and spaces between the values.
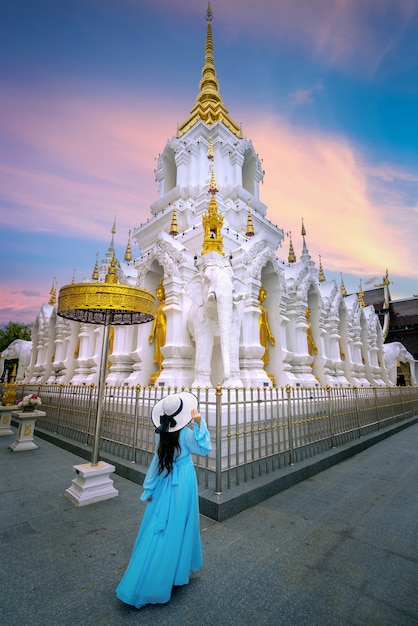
186, 259, 245, 387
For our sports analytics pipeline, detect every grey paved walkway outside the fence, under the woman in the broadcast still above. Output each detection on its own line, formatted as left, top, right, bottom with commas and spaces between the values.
0, 424, 418, 626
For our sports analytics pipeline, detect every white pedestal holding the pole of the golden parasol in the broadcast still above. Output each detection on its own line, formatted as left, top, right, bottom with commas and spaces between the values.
65, 461, 119, 506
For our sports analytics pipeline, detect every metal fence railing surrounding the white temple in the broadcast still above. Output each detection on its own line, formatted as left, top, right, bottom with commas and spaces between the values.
4, 385, 418, 493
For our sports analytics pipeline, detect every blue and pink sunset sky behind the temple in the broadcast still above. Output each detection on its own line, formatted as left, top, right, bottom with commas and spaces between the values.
0, 0, 418, 324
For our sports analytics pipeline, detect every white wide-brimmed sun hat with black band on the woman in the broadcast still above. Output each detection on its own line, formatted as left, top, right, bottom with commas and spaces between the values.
151, 391, 199, 433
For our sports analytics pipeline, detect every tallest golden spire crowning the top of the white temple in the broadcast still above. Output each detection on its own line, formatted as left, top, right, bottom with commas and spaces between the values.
177, 2, 242, 138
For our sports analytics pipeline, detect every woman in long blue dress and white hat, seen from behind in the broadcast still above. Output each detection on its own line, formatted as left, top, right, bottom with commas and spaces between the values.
116, 391, 212, 609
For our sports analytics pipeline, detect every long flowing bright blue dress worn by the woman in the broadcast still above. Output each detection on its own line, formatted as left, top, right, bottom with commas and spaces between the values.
116, 418, 212, 609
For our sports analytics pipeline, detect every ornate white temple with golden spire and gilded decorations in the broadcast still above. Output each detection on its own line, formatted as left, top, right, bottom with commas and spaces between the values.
22, 5, 412, 387
